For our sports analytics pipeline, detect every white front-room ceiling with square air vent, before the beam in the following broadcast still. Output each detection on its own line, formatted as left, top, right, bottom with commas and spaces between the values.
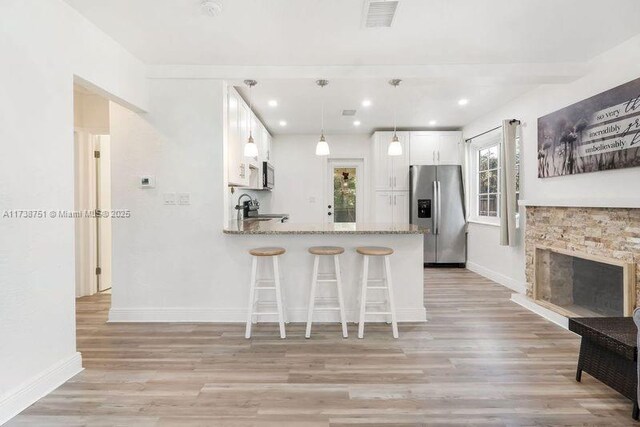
66, 0, 640, 65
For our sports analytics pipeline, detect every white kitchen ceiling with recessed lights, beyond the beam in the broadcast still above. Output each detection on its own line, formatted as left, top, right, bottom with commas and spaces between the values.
235, 79, 533, 134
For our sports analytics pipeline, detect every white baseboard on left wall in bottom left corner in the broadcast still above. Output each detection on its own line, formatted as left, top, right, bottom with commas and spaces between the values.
0, 353, 82, 425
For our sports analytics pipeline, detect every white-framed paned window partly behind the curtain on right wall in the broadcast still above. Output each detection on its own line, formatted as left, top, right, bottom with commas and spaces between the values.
468, 130, 520, 224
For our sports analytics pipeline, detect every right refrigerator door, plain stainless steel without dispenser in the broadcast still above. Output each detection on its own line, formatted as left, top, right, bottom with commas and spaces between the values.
437, 166, 466, 263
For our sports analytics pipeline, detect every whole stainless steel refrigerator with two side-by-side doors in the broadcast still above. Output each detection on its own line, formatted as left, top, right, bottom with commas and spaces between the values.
410, 165, 467, 264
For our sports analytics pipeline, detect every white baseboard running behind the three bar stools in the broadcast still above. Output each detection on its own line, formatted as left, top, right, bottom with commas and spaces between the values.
109, 307, 427, 323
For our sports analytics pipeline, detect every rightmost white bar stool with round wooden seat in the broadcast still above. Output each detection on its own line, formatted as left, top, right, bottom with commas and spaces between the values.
356, 246, 398, 338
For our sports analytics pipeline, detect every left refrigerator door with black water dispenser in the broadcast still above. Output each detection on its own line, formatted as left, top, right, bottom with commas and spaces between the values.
409, 166, 437, 263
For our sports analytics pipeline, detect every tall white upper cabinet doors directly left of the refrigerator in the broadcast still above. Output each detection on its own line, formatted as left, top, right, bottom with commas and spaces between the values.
373, 132, 410, 191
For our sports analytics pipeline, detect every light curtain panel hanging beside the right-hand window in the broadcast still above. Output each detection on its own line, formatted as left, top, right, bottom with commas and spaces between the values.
500, 120, 520, 246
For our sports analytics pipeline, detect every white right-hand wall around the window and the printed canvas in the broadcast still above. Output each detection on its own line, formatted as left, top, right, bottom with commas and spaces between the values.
463, 36, 640, 290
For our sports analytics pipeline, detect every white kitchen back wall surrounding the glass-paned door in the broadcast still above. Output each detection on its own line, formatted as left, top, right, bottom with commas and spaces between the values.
271, 134, 371, 223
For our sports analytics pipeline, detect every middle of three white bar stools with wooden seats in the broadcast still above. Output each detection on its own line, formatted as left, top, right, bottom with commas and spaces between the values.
304, 246, 348, 338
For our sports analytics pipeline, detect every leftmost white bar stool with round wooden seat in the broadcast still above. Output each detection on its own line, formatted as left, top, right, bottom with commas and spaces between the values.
244, 247, 286, 338
